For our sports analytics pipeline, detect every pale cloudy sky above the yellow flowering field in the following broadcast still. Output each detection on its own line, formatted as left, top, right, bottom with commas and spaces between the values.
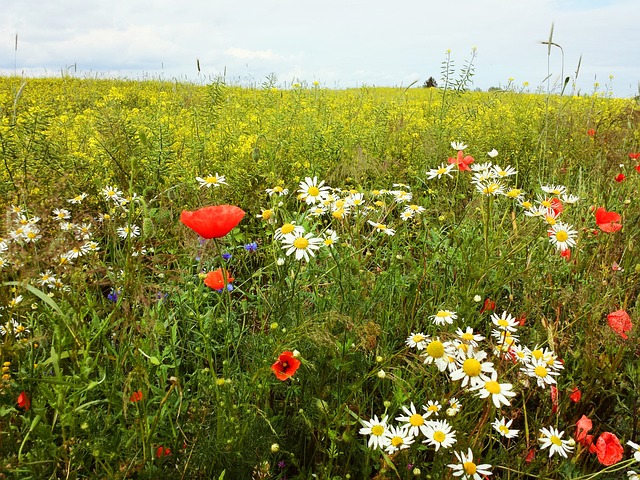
0, 0, 640, 97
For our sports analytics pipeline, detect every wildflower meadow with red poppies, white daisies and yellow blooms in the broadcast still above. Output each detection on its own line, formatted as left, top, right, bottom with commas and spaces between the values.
0, 72, 640, 480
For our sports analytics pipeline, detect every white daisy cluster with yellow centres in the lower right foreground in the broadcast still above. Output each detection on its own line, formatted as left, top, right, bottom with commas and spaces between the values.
360, 309, 573, 468
